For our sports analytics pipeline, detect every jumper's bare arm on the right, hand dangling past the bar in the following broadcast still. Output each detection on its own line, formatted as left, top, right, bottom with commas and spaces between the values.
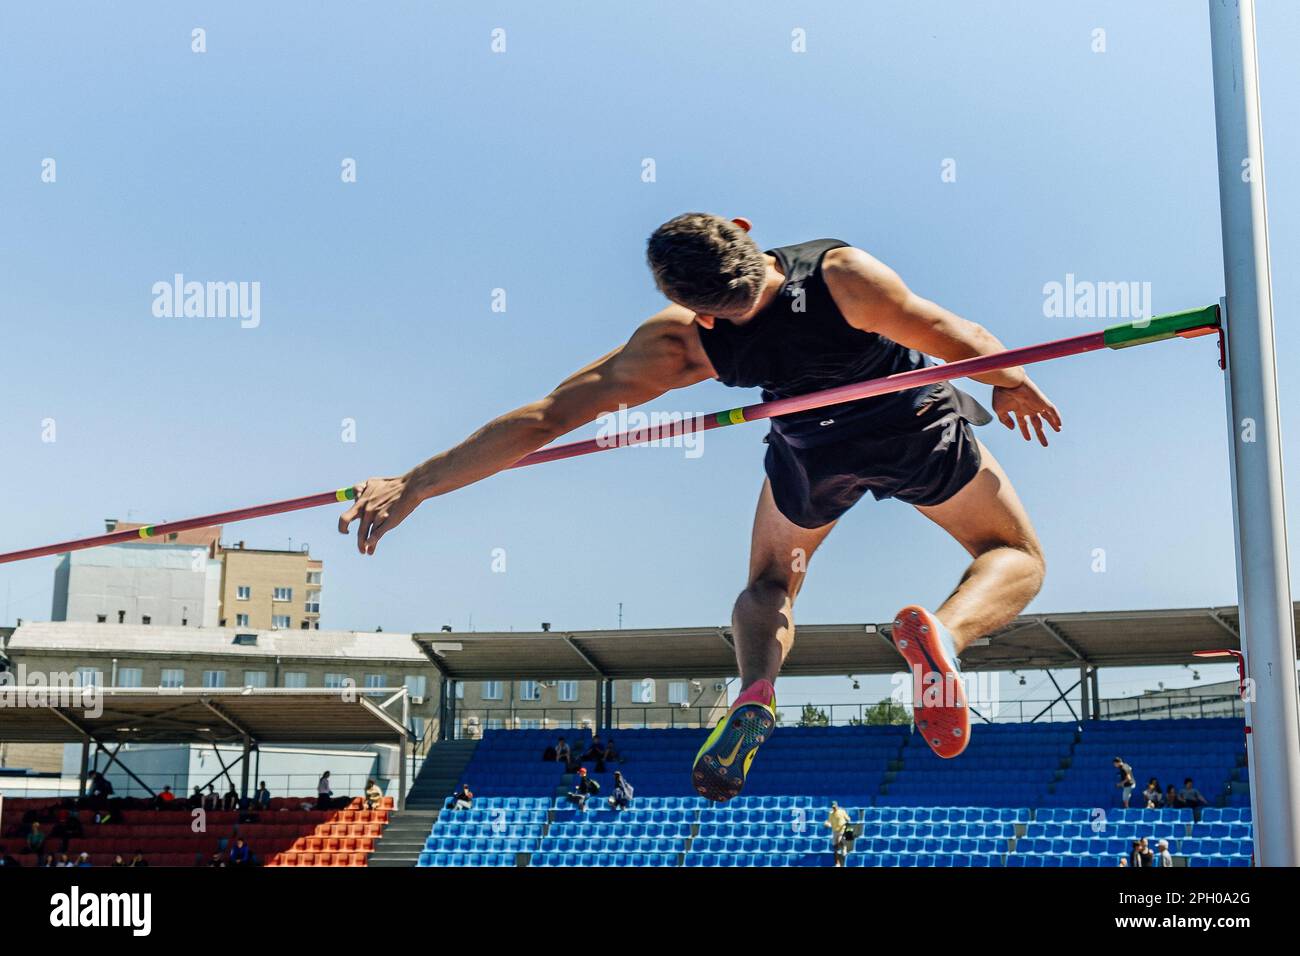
822, 248, 1061, 445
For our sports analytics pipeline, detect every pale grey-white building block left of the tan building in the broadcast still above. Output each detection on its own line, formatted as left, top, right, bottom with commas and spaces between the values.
49, 541, 221, 627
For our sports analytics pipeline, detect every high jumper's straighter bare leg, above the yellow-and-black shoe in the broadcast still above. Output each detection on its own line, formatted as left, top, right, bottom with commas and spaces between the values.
732, 481, 835, 689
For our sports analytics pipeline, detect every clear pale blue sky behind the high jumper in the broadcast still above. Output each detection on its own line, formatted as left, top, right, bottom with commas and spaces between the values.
0, 0, 1300, 700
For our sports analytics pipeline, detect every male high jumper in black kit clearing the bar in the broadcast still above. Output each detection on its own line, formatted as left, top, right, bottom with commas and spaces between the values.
338, 213, 1061, 801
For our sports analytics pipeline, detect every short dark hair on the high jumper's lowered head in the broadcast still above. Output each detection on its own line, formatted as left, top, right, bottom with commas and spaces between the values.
646, 212, 767, 316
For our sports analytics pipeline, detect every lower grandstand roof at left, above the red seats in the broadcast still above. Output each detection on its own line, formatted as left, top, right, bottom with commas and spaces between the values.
0, 685, 402, 744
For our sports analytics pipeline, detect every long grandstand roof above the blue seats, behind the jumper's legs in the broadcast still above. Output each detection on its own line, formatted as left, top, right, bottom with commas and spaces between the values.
413, 606, 1279, 680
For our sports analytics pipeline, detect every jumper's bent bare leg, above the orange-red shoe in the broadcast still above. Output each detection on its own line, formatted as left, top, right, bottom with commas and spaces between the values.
917, 444, 1045, 653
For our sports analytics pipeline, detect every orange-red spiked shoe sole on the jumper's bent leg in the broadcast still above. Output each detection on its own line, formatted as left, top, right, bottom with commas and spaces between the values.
889, 605, 971, 758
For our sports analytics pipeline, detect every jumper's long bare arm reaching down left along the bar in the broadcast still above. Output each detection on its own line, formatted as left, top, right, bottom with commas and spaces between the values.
338, 306, 714, 554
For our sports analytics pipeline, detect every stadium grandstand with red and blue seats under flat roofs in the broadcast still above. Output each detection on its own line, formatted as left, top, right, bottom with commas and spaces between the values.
0, 607, 1274, 868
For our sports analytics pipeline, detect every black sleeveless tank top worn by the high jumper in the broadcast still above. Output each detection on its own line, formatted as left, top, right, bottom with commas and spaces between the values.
697, 239, 978, 447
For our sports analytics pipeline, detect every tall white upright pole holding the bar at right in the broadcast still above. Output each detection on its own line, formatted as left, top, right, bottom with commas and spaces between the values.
1209, 0, 1300, 866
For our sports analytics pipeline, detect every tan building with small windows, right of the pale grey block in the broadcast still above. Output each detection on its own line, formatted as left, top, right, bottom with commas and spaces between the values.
215, 541, 324, 631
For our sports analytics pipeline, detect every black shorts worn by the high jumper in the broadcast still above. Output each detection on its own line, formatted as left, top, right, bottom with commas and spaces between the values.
763, 386, 992, 528
